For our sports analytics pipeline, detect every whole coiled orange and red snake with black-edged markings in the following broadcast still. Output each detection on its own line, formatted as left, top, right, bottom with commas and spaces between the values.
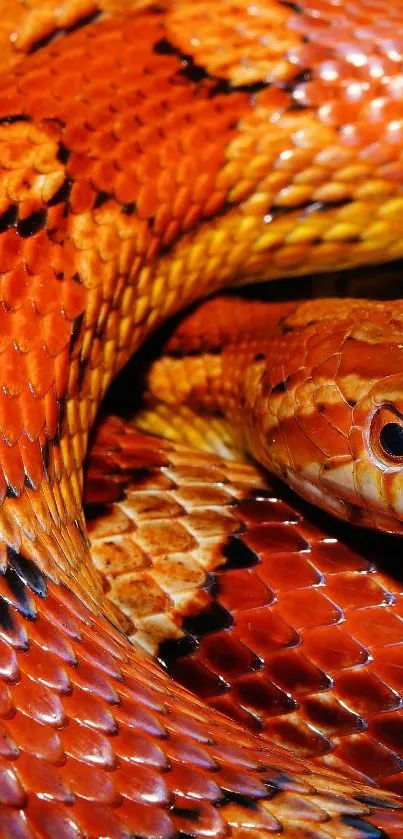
0, 0, 403, 839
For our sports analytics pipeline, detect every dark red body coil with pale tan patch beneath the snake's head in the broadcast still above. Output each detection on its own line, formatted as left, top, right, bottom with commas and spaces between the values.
84, 420, 403, 794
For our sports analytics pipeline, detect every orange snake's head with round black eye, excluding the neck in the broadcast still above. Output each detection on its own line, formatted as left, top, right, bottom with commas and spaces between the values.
247, 300, 403, 535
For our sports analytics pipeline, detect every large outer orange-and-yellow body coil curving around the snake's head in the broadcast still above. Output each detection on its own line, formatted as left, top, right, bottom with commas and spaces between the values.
0, 0, 403, 839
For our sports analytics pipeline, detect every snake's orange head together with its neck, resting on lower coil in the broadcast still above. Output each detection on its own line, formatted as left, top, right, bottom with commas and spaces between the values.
139, 297, 403, 533
